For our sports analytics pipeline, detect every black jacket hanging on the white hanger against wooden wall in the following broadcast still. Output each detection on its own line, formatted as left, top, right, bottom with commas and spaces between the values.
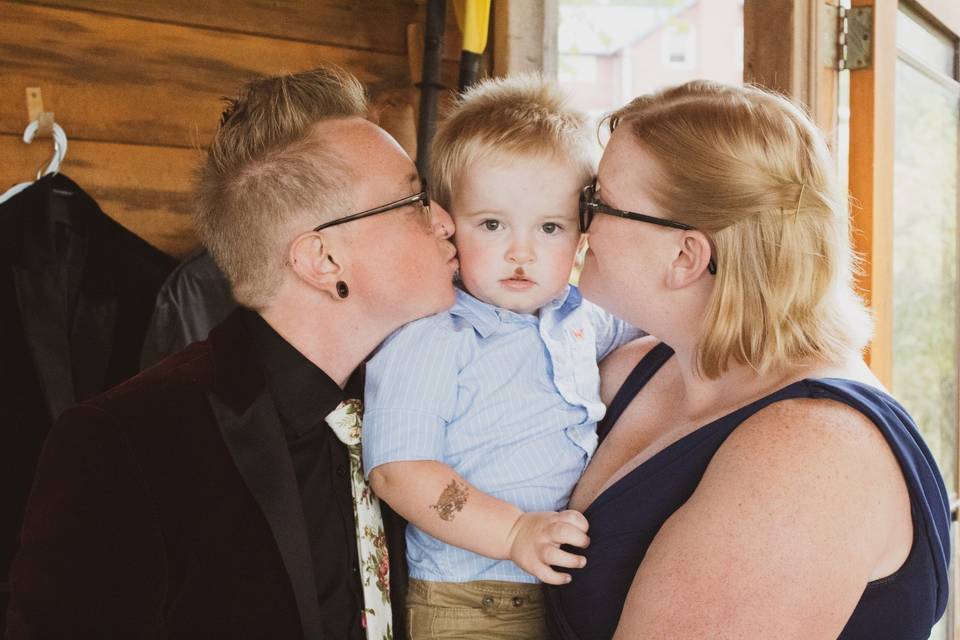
0, 174, 176, 629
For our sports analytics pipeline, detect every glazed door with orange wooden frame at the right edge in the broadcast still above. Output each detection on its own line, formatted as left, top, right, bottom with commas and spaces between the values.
838, 0, 960, 640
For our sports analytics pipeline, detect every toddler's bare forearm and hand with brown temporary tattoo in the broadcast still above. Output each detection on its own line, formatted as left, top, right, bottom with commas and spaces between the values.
369, 461, 590, 584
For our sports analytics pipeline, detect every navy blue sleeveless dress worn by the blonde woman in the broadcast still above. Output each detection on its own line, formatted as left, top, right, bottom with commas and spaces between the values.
546, 343, 950, 640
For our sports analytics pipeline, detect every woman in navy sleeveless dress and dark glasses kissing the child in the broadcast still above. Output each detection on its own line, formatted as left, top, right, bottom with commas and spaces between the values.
548, 82, 949, 640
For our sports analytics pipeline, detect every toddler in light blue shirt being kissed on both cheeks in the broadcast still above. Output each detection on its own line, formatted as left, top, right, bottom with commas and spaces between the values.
364, 76, 639, 640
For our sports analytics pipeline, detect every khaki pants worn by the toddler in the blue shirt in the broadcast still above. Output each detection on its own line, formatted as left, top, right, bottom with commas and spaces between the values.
407, 579, 548, 640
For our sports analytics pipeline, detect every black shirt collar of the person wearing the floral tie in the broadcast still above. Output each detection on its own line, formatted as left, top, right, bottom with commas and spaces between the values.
244, 311, 363, 436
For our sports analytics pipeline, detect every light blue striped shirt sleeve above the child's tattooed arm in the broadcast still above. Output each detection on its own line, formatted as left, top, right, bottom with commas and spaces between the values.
363, 314, 460, 476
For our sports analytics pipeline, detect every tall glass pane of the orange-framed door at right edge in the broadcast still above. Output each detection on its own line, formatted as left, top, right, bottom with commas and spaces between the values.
892, 7, 960, 498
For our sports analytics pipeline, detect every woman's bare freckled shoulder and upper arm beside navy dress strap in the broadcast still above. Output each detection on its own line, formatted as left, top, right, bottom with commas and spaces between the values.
617, 398, 911, 638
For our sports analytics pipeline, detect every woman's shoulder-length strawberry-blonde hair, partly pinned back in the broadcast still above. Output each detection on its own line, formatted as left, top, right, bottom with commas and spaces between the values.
609, 81, 872, 378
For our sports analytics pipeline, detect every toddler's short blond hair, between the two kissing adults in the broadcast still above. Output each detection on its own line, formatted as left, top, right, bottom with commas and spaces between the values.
430, 74, 594, 208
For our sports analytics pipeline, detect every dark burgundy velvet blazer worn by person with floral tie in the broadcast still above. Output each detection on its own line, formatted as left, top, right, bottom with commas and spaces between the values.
7, 313, 406, 640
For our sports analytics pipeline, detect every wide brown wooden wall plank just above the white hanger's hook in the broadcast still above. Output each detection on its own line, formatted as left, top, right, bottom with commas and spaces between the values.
0, 3, 458, 149
